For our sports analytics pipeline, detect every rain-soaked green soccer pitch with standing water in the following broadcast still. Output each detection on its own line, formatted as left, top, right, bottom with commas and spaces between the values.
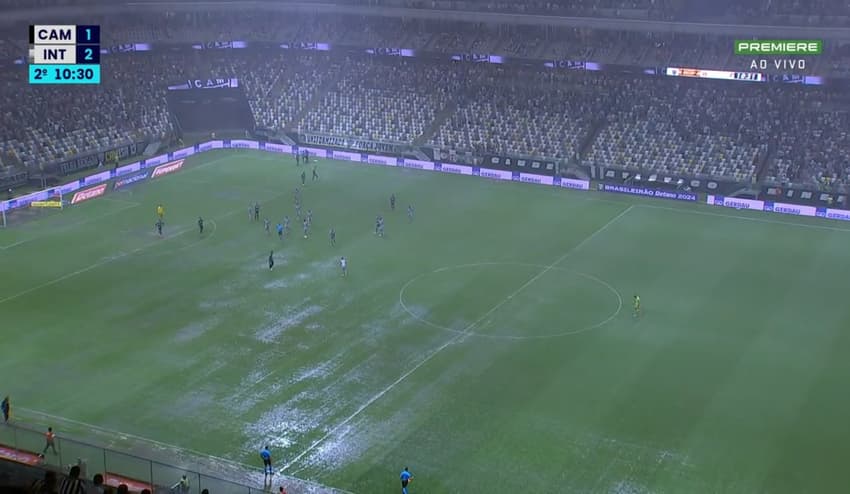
0, 151, 850, 494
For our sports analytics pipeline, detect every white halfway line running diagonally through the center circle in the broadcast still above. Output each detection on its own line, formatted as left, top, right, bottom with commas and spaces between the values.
279, 205, 634, 473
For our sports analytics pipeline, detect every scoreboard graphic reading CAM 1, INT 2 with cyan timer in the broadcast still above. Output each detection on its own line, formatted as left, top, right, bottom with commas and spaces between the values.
29, 25, 100, 84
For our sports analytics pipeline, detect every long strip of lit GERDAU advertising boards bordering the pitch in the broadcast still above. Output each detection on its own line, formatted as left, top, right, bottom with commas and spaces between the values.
0, 139, 850, 221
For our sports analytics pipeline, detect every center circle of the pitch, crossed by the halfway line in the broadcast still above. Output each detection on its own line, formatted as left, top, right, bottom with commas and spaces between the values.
398, 262, 623, 340
